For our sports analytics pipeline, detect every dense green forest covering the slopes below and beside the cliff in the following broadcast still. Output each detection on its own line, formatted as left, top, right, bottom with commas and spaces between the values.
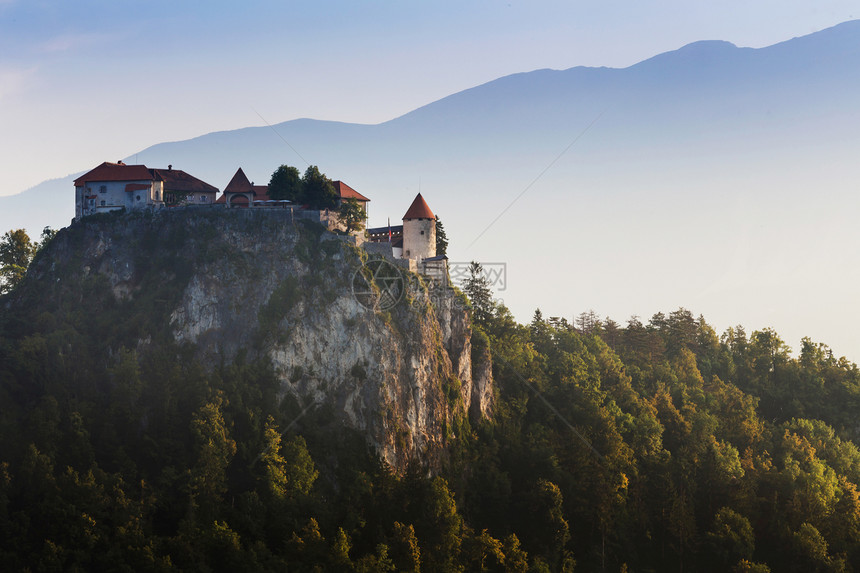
0, 226, 860, 572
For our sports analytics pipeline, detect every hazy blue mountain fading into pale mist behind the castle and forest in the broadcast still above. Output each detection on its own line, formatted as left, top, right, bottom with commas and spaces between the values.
6, 21, 860, 358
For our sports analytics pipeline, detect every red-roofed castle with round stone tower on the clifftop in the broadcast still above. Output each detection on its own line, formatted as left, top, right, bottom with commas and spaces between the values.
74, 161, 447, 270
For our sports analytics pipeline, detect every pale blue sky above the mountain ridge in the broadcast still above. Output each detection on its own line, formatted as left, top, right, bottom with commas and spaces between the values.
0, 0, 860, 195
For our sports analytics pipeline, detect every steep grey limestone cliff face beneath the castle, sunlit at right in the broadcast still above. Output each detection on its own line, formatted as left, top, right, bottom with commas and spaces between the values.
32, 209, 493, 470
